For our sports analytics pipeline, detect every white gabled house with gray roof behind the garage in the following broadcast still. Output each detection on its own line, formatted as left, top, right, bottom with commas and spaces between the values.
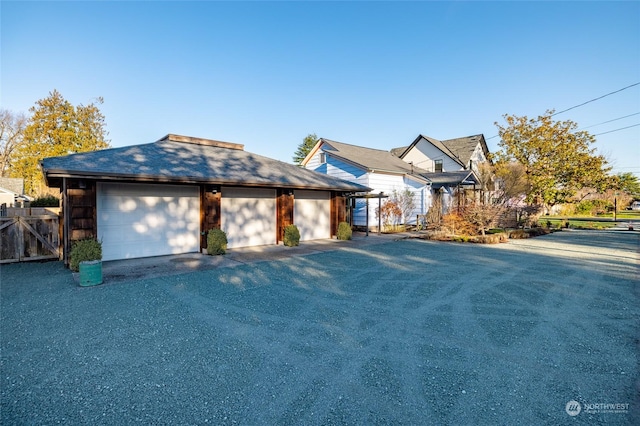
302, 135, 489, 230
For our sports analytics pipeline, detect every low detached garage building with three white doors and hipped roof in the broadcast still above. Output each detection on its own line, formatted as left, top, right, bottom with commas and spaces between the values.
41, 134, 368, 263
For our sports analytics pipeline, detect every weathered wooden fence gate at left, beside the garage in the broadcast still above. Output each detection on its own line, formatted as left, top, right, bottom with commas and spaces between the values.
0, 215, 60, 263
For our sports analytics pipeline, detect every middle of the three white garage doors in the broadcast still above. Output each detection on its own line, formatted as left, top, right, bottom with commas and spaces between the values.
220, 187, 277, 248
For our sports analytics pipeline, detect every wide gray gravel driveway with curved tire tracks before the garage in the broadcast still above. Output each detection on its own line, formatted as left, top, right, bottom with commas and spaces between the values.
0, 231, 640, 425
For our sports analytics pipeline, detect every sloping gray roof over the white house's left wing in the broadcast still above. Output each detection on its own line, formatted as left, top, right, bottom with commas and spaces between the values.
321, 138, 426, 174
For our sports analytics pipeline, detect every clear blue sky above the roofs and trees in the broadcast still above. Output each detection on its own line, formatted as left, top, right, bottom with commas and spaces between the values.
0, 1, 640, 175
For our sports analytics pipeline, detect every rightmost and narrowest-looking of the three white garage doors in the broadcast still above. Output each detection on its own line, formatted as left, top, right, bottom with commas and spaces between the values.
293, 190, 331, 241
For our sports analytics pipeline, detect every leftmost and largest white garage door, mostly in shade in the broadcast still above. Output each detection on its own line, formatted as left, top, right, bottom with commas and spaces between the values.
97, 183, 200, 260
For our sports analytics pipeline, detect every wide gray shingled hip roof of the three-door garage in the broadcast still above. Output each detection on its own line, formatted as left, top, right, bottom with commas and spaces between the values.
42, 135, 369, 191
